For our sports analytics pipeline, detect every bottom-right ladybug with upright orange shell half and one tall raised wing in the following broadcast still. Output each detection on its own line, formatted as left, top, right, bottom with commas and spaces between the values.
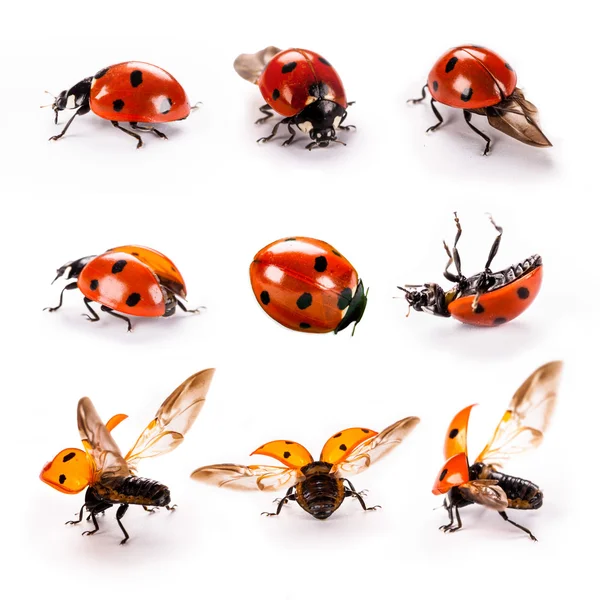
432, 361, 562, 541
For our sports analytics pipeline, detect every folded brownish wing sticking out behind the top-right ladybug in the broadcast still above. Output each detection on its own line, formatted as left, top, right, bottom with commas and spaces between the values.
486, 89, 552, 147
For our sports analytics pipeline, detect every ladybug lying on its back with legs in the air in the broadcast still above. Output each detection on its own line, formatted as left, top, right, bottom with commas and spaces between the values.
398, 213, 543, 327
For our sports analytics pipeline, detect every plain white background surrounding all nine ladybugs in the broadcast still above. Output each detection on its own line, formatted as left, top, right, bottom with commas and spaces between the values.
0, 0, 599, 600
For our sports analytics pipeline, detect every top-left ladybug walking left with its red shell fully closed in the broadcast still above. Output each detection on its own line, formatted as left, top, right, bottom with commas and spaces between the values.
50, 61, 196, 148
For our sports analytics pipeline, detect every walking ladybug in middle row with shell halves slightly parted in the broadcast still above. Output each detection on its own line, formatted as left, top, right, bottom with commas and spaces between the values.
45, 246, 200, 331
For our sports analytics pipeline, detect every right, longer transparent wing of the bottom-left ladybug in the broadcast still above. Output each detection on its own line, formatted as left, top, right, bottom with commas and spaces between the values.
125, 369, 215, 471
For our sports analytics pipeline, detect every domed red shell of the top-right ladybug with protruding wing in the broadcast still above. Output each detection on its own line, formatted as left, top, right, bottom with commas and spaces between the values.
427, 46, 517, 108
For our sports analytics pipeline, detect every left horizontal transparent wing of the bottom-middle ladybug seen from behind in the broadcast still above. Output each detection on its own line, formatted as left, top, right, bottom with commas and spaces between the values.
191, 464, 304, 491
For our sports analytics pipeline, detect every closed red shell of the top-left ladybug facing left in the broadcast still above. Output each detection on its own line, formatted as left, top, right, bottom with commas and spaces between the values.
90, 61, 190, 123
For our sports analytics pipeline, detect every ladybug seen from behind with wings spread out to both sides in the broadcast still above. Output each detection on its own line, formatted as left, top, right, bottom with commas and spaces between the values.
191, 417, 419, 520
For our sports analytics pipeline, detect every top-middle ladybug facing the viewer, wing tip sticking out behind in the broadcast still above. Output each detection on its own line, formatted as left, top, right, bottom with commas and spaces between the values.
233, 46, 355, 150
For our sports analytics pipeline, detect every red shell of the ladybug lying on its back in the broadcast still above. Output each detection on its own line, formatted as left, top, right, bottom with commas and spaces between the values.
448, 265, 543, 327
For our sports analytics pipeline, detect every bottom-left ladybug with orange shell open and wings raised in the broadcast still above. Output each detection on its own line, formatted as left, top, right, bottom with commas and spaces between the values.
40, 369, 214, 544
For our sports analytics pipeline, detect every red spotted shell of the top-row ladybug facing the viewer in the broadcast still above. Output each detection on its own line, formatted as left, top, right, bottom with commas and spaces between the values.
257, 48, 348, 117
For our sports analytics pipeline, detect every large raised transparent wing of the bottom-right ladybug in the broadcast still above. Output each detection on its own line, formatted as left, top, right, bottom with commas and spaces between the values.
476, 361, 563, 467
